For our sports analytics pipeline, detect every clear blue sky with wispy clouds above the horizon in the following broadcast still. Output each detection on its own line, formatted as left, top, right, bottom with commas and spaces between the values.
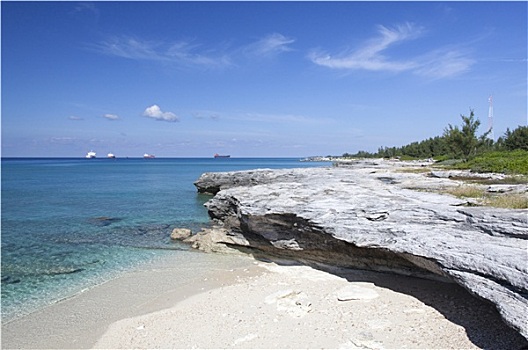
1, 1, 528, 157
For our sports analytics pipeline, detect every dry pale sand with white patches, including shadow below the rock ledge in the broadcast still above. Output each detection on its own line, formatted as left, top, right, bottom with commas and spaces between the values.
95, 262, 524, 349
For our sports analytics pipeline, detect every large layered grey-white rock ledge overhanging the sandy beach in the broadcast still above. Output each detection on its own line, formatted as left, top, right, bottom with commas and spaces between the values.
195, 162, 528, 339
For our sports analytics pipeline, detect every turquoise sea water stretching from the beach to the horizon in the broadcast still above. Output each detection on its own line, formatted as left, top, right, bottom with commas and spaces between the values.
1, 158, 329, 322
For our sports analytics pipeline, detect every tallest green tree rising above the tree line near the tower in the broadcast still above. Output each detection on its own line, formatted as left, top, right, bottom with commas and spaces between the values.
444, 110, 490, 159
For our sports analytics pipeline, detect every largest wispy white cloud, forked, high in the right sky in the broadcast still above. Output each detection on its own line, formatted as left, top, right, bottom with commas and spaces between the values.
308, 23, 474, 78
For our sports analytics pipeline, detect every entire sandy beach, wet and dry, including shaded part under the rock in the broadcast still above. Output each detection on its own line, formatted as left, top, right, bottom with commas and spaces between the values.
2, 253, 526, 349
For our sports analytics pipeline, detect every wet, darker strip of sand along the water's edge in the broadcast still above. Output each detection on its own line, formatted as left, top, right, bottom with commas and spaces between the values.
2, 251, 260, 349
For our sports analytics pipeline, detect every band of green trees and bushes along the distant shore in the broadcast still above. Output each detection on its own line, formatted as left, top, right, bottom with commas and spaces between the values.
343, 110, 528, 175
